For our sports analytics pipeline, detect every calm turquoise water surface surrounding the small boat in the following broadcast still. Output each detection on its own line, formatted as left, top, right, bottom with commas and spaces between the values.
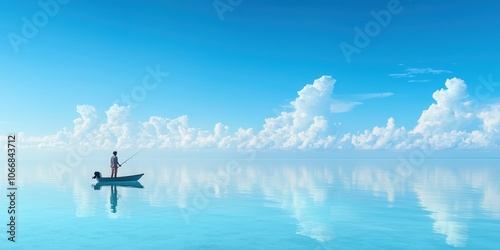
0, 159, 500, 249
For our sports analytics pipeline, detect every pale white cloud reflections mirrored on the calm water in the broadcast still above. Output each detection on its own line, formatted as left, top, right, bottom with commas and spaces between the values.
22, 161, 500, 247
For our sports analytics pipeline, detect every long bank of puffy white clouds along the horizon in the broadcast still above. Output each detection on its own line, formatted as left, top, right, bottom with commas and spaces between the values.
20, 76, 500, 150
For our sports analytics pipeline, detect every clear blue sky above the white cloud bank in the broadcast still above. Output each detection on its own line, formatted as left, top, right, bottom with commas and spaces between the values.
0, 0, 500, 148
